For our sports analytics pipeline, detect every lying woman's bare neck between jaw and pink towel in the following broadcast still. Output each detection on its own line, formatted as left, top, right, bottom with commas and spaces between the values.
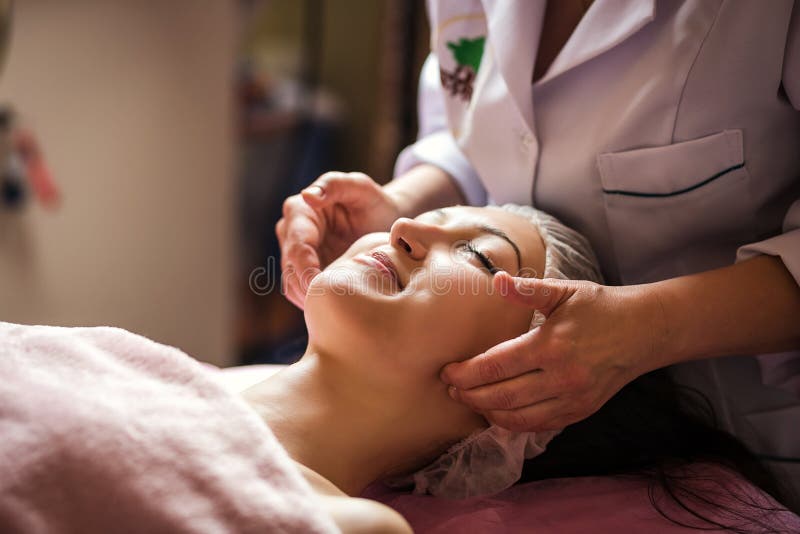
245, 349, 474, 495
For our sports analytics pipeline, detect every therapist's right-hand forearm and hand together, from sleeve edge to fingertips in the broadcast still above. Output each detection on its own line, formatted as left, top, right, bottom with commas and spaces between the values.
441, 256, 800, 431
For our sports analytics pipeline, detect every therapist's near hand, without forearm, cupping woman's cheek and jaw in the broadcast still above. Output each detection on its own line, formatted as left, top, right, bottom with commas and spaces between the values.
441, 272, 669, 431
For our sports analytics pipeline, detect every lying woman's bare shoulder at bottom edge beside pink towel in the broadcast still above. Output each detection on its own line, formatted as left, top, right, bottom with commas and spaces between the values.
322, 495, 414, 534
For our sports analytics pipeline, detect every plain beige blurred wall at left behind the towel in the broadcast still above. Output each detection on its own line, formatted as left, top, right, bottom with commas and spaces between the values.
0, 0, 238, 364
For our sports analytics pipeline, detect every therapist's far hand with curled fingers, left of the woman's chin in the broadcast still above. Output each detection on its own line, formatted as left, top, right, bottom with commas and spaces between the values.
275, 172, 399, 309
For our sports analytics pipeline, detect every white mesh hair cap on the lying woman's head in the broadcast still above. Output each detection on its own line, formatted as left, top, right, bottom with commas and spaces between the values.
389, 204, 603, 499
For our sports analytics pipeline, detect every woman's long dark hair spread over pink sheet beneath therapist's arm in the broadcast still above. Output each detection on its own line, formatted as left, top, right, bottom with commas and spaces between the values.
521, 370, 784, 532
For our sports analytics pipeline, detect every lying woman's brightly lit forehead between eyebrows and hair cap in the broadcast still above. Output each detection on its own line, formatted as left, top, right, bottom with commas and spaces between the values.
422, 206, 545, 273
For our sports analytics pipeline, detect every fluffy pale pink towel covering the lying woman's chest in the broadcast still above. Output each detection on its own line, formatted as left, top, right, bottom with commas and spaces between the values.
0, 323, 338, 533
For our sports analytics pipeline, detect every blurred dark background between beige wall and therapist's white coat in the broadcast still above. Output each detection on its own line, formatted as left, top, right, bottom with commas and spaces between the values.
236, 0, 428, 363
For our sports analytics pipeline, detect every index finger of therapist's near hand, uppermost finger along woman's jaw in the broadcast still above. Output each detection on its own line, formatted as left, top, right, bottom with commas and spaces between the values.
440, 331, 538, 389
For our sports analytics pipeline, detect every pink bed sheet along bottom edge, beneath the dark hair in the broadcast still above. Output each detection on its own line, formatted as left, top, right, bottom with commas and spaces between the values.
366, 477, 800, 534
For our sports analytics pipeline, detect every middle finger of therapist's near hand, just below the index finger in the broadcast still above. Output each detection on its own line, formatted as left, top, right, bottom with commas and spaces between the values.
448, 371, 556, 412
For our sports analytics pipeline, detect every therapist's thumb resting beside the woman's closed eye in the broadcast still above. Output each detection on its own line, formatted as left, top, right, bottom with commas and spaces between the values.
494, 271, 576, 317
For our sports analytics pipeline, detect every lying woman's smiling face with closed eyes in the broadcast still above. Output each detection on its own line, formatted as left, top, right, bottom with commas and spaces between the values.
305, 207, 544, 383
